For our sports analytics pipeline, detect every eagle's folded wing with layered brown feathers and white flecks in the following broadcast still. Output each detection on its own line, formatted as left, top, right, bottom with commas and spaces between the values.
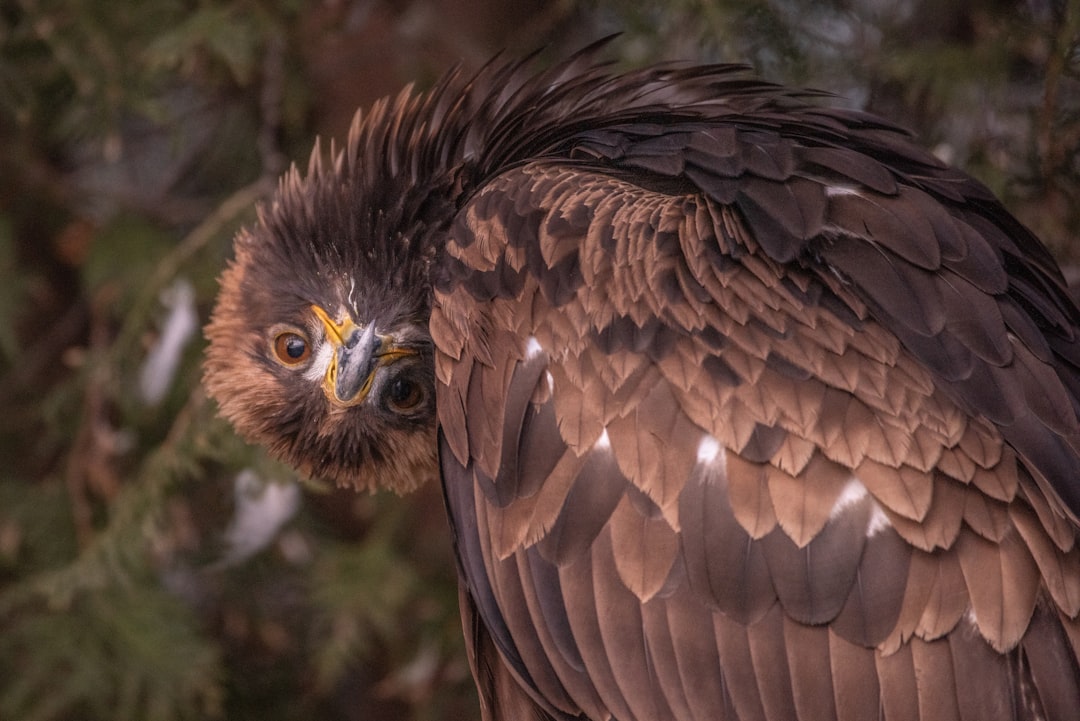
431, 91, 1080, 721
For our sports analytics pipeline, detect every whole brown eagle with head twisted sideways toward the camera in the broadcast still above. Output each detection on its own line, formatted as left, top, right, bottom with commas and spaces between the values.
206, 46, 1080, 721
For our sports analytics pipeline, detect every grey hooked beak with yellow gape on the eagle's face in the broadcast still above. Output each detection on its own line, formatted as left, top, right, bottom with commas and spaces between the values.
311, 305, 415, 407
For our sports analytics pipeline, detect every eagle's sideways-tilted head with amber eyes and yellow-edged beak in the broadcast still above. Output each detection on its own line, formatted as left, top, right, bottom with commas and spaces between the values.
204, 114, 448, 492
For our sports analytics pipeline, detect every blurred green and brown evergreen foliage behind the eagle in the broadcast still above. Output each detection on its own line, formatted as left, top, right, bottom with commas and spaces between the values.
0, 0, 1080, 721
